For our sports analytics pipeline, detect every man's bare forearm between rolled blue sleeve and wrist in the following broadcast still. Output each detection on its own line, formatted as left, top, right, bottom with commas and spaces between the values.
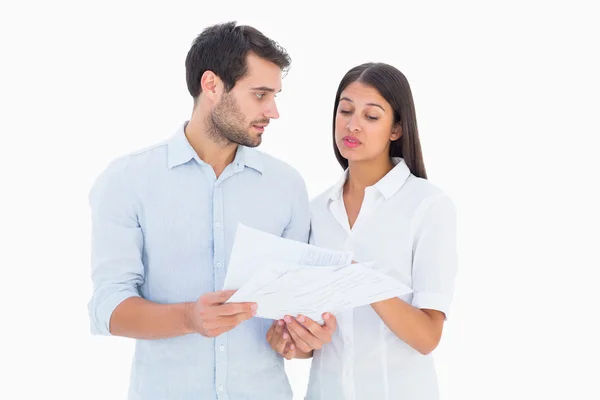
110, 297, 193, 339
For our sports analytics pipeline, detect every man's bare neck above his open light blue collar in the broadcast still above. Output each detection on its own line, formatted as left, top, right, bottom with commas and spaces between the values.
185, 111, 238, 177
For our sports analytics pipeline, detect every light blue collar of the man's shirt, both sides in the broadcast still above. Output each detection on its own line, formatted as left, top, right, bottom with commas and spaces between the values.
167, 121, 263, 174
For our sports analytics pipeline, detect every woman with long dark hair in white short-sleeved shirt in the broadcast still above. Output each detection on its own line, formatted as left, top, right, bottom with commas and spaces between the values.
267, 63, 457, 400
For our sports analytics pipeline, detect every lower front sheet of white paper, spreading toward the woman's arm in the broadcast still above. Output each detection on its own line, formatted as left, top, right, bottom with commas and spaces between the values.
228, 263, 412, 324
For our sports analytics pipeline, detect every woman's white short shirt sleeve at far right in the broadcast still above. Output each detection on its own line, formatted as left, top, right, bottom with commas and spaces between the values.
412, 194, 458, 318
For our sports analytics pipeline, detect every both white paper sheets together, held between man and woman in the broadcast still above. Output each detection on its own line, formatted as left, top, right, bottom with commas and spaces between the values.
224, 225, 412, 324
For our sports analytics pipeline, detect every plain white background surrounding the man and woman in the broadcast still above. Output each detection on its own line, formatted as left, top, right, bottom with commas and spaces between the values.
0, 0, 600, 400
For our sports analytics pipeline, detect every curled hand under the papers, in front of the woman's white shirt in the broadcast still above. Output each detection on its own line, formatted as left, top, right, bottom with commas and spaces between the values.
284, 313, 337, 353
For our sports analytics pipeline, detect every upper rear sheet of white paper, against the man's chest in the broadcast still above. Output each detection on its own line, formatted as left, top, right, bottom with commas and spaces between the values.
223, 224, 353, 290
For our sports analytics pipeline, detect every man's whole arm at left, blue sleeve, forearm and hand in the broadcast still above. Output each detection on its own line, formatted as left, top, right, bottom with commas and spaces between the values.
88, 160, 255, 339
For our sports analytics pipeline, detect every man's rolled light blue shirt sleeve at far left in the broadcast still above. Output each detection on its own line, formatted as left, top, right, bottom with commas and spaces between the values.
88, 164, 144, 335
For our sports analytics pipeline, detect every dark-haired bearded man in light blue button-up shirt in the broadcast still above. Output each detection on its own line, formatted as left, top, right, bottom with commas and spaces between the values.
89, 23, 332, 400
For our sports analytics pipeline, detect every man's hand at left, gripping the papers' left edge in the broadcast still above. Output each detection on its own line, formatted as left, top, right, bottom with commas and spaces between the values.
187, 290, 257, 337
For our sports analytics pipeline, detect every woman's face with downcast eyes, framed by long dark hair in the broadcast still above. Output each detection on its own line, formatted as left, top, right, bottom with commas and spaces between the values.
335, 82, 402, 164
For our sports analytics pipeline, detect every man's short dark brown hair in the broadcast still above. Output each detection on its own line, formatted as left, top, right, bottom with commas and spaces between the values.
185, 21, 291, 101
